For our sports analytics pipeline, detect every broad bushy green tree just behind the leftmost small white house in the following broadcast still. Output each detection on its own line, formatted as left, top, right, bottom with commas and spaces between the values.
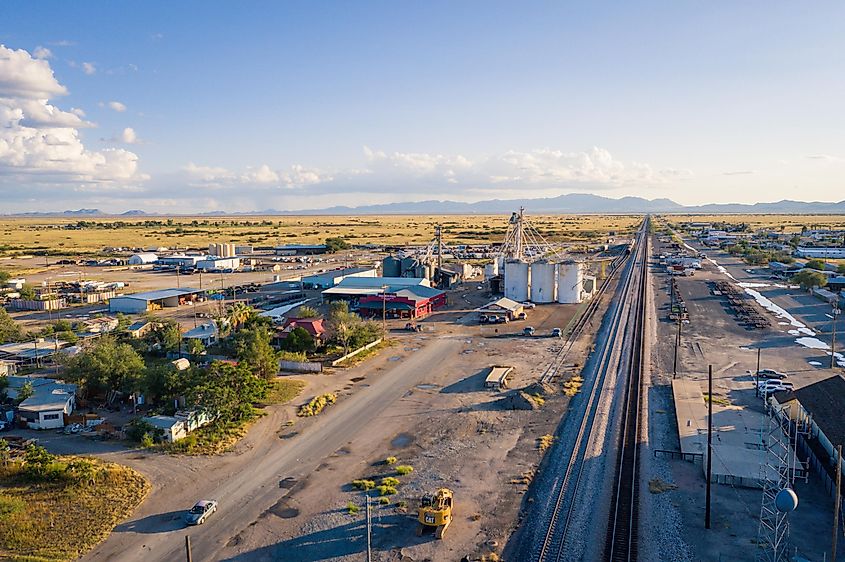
64, 336, 146, 395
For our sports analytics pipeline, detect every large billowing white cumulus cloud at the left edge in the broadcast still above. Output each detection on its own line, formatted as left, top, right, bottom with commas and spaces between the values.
0, 45, 144, 184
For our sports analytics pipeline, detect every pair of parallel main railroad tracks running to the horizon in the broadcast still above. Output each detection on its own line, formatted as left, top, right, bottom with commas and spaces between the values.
536, 220, 648, 562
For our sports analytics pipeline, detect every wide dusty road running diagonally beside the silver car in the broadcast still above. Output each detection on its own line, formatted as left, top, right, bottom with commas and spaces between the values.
83, 338, 461, 562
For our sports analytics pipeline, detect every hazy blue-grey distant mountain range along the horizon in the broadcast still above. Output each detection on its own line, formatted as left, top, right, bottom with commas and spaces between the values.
6, 193, 845, 218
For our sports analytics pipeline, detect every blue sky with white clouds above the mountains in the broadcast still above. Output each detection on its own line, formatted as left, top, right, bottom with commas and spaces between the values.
0, 0, 845, 214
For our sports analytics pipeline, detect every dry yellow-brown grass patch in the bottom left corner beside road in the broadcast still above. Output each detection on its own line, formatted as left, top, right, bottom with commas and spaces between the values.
0, 457, 150, 560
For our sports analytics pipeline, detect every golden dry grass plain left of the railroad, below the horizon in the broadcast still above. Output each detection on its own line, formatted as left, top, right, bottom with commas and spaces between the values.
0, 215, 642, 256
